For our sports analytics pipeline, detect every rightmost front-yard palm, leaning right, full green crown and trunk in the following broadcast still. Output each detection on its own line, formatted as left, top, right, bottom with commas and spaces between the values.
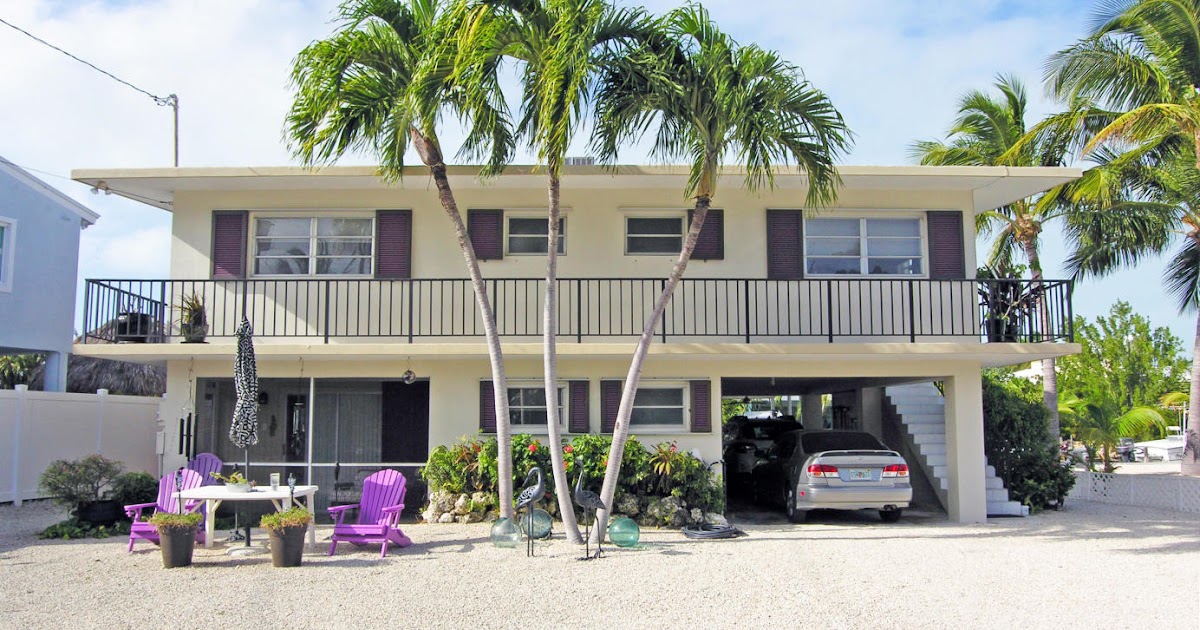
594, 5, 851, 530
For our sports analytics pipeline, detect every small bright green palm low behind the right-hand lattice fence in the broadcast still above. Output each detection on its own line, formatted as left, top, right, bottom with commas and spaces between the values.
1062, 394, 1166, 473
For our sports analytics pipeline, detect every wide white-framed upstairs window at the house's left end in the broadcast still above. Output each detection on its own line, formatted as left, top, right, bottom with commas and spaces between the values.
253, 216, 374, 276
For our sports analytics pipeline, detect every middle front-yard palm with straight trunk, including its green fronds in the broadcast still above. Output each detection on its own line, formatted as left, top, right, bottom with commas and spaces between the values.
467, 0, 646, 542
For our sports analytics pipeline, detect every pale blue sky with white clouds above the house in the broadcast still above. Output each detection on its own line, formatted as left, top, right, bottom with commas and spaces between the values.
0, 0, 1195, 347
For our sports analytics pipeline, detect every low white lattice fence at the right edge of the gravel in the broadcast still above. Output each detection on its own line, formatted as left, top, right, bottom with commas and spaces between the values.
1070, 470, 1200, 512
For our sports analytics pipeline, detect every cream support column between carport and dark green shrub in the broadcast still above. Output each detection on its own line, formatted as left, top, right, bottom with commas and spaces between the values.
944, 365, 988, 523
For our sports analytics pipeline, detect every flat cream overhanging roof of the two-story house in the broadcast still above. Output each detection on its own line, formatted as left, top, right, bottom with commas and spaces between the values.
71, 166, 1082, 211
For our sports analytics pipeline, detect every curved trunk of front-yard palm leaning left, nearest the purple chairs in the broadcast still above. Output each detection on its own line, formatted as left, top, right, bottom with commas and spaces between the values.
409, 128, 512, 518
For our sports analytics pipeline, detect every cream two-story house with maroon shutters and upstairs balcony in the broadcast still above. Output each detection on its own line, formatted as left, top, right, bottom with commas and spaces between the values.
74, 162, 1080, 522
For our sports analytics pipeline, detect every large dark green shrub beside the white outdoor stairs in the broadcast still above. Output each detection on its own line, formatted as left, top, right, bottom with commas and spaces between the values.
983, 370, 1075, 511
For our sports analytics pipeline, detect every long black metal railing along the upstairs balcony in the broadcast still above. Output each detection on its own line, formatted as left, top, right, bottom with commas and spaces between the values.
83, 278, 1074, 343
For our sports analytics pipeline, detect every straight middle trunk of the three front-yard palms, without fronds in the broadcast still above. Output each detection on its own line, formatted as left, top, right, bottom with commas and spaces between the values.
541, 168, 583, 545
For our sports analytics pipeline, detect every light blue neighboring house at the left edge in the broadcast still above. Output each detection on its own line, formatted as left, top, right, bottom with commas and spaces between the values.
0, 157, 100, 391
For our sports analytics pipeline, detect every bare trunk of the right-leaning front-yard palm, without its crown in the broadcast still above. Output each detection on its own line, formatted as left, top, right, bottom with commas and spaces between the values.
593, 194, 712, 540
